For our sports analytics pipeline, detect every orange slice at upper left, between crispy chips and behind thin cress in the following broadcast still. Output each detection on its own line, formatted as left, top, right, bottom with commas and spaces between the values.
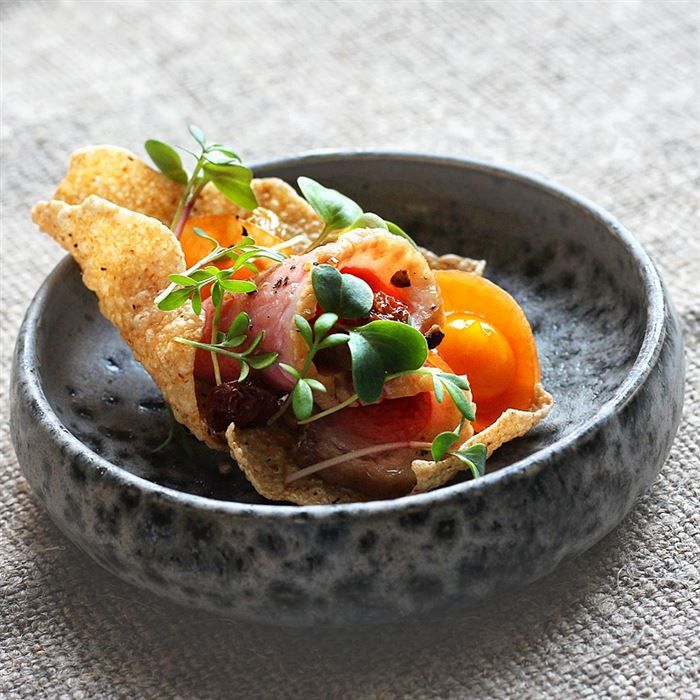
180, 214, 285, 299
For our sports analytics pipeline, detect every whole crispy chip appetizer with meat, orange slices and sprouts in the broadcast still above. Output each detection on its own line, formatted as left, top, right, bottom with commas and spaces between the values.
33, 127, 552, 504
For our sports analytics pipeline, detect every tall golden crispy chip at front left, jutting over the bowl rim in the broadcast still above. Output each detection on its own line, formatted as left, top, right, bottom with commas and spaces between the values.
32, 195, 221, 447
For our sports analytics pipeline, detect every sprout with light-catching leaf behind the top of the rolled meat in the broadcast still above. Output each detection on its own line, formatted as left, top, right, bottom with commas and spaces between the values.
297, 177, 416, 250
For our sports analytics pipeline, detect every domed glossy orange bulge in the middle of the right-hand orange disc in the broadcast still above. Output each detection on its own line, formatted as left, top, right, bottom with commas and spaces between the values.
440, 313, 515, 399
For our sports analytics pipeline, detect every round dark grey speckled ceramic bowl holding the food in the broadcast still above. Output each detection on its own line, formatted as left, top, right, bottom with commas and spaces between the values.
12, 153, 684, 625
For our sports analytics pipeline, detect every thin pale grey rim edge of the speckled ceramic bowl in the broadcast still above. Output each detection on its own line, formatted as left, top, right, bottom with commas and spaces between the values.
19, 150, 666, 520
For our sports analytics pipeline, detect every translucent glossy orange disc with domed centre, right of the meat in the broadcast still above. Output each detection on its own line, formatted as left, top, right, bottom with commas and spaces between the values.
435, 270, 540, 432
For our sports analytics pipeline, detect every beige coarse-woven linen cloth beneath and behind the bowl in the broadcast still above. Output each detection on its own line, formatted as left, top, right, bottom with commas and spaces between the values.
0, 0, 700, 698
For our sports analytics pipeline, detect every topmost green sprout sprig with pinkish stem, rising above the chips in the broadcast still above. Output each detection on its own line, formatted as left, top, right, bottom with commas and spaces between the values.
144, 124, 258, 238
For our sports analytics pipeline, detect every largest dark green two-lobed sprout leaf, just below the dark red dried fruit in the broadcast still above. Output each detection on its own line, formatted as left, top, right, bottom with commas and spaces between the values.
348, 321, 428, 403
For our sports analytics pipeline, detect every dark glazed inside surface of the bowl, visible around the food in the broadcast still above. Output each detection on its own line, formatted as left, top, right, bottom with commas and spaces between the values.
31, 155, 647, 503
